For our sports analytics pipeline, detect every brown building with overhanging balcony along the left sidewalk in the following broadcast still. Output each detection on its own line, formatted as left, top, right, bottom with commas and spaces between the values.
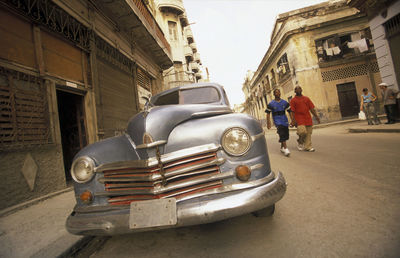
0, 0, 173, 209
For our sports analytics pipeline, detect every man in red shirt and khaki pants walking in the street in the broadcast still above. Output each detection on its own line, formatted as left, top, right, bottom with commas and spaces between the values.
290, 86, 320, 151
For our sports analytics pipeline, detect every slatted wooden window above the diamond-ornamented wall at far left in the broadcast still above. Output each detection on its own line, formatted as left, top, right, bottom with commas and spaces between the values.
0, 67, 51, 150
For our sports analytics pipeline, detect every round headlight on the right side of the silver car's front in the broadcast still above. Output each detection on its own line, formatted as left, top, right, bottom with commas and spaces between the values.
221, 127, 251, 156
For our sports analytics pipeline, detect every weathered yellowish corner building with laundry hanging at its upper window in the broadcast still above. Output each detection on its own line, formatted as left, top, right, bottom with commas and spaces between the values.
246, 0, 381, 121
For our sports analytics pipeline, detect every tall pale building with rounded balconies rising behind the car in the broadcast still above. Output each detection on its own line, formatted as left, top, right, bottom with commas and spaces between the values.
149, 0, 202, 90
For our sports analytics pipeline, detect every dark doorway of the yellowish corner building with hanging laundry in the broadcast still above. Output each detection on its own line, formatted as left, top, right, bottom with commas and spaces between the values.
336, 82, 360, 118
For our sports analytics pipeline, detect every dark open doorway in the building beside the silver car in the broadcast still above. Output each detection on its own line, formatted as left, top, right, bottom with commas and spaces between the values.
57, 90, 87, 182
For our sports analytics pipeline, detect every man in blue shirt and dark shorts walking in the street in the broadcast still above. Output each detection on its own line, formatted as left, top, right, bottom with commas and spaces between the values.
265, 89, 292, 157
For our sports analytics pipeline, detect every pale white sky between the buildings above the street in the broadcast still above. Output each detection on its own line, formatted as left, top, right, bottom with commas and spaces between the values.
183, 0, 324, 107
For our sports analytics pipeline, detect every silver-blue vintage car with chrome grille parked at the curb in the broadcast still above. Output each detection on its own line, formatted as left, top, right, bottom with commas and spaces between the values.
66, 83, 286, 235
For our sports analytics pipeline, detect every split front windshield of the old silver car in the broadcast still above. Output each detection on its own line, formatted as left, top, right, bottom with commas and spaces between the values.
154, 87, 220, 106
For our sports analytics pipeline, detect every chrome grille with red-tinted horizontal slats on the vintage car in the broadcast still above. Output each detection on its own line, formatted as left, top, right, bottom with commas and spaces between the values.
96, 145, 226, 205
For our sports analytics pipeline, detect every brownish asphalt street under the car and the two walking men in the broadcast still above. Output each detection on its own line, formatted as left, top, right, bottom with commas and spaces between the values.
87, 125, 400, 258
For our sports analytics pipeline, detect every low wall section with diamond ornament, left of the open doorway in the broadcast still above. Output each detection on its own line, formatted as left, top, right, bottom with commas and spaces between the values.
0, 145, 66, 210
